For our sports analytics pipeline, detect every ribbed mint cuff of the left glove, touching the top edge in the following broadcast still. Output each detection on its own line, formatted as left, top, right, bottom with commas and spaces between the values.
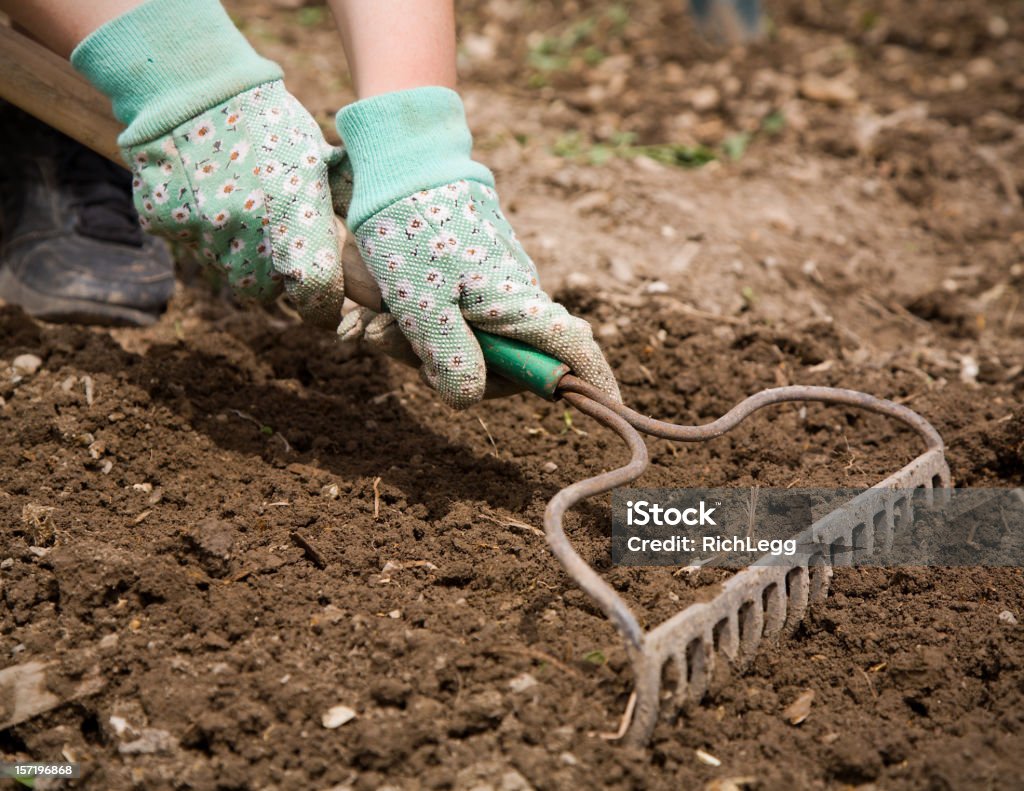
71, 0, 282, 147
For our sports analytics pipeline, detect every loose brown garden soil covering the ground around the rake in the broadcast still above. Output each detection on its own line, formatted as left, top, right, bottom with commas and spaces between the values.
0, 0, 1024, 791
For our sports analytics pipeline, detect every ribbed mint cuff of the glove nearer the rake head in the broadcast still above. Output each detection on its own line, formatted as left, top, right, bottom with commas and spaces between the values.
336, 88, 495, 231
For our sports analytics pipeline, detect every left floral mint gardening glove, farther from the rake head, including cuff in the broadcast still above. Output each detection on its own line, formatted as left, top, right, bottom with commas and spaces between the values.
71, 0, 350, 329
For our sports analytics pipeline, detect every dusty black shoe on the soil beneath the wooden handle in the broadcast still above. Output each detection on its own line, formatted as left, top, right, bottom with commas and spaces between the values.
0, 102, 174, 326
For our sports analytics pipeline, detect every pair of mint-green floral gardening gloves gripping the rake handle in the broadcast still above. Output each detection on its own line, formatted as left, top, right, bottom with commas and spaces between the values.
72, 0, 618, 408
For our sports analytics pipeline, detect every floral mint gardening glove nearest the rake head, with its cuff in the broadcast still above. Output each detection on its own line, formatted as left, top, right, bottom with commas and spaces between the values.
337, 87, 618, 409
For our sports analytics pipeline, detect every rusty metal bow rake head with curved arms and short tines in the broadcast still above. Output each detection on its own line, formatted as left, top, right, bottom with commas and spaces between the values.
544, 375, 949, 744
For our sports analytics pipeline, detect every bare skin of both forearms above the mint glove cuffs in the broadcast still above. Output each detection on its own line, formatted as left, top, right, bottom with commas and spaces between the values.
0, 0, 456, 98
